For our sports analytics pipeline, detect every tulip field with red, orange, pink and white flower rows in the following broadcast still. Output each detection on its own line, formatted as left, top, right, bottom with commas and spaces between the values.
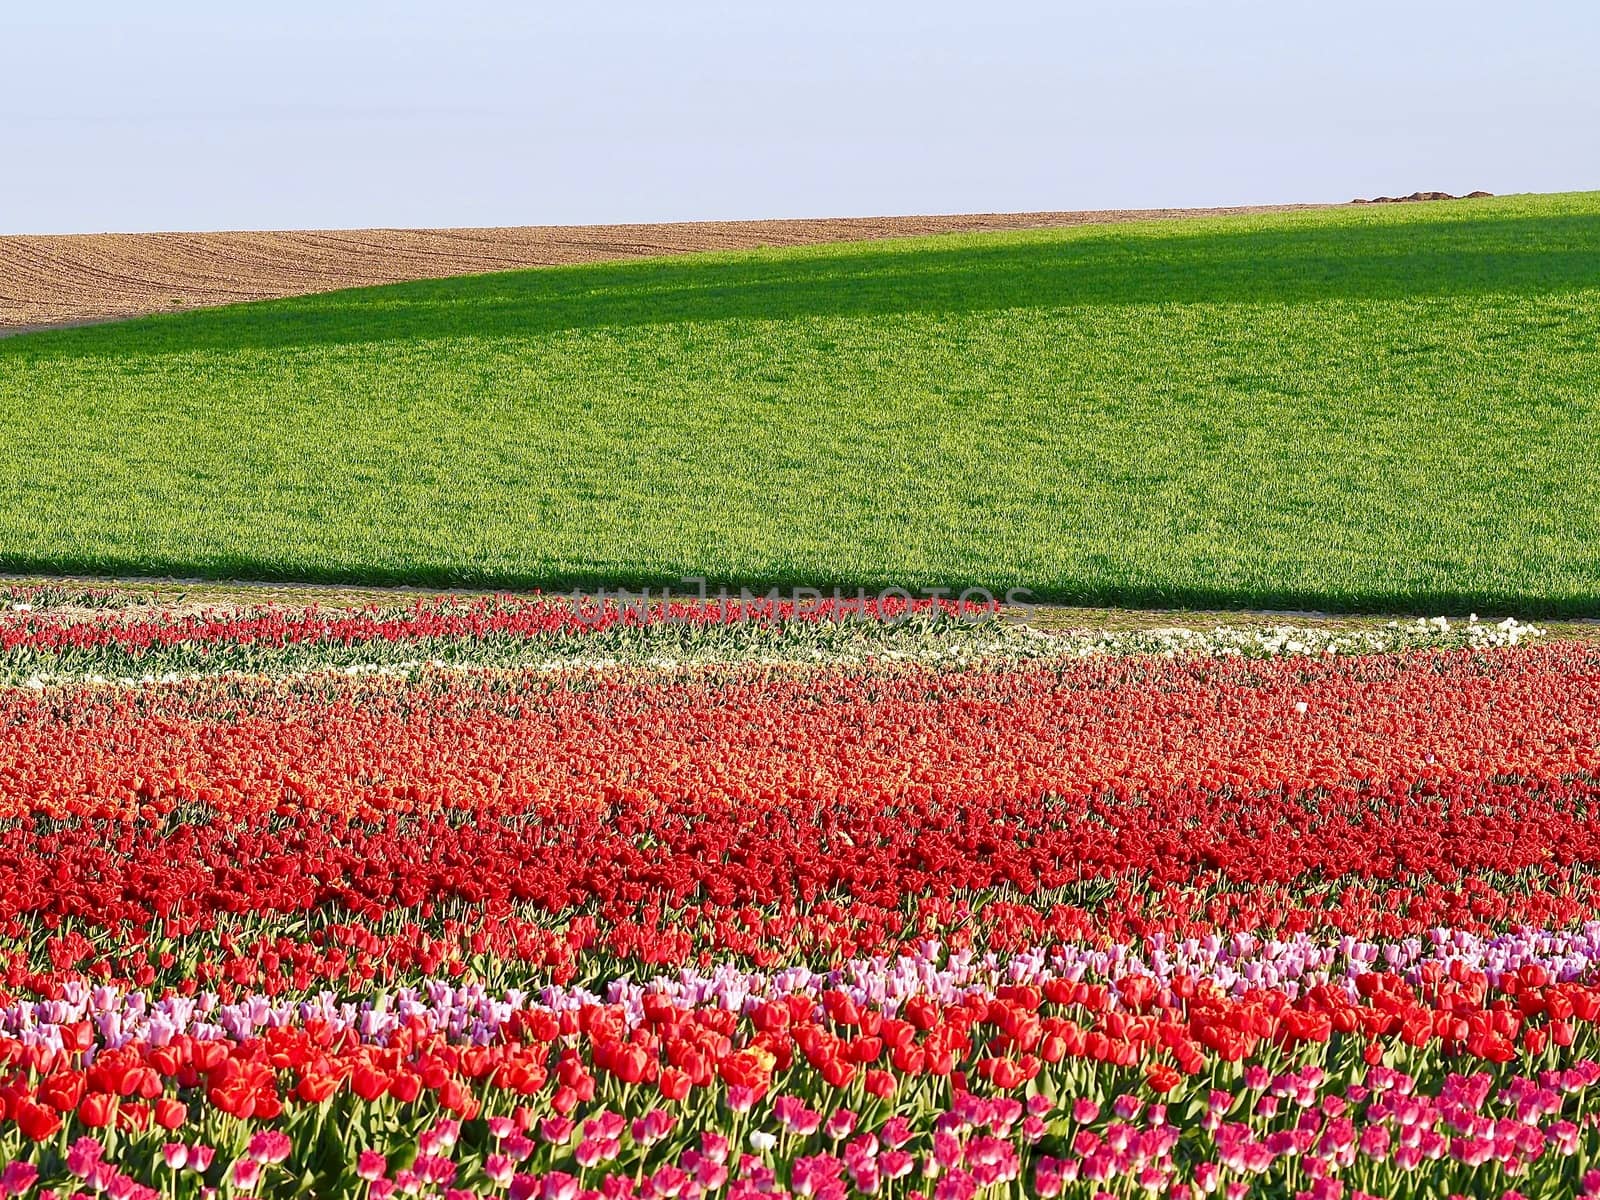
0, 589, 1600, 1200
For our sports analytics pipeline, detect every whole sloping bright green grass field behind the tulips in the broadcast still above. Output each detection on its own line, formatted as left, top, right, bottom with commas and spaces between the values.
0, 194, 1600, 616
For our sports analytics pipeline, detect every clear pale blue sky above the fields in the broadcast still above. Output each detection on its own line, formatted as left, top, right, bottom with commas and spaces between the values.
0, 0, 1600, 234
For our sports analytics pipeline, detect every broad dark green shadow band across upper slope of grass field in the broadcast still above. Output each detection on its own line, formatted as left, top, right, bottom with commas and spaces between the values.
12, 214, 1600, 358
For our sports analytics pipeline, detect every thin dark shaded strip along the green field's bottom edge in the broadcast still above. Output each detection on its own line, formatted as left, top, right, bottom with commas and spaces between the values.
0, 554, 1600, 619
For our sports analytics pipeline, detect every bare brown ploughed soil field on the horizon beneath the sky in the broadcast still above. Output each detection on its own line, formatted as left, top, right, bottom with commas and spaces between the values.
0, 205, 1331, 334
